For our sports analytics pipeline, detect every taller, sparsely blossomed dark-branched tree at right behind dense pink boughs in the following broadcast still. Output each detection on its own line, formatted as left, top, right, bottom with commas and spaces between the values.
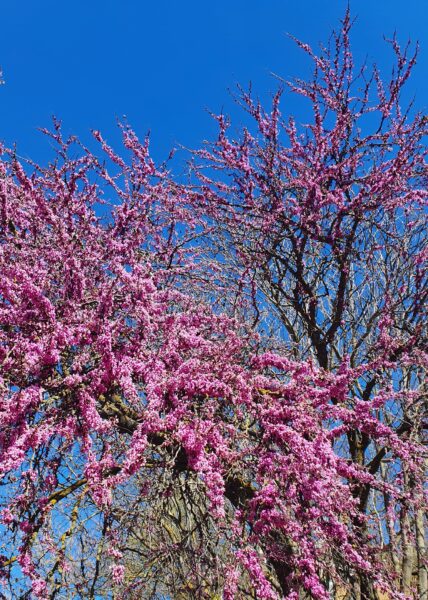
194, 12, 428, 597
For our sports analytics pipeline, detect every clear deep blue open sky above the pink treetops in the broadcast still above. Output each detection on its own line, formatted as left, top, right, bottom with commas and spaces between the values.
0, 0, 428, 166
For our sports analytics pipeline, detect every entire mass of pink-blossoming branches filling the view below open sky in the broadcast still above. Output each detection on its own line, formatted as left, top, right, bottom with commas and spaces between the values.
0, 10, 426, 600
